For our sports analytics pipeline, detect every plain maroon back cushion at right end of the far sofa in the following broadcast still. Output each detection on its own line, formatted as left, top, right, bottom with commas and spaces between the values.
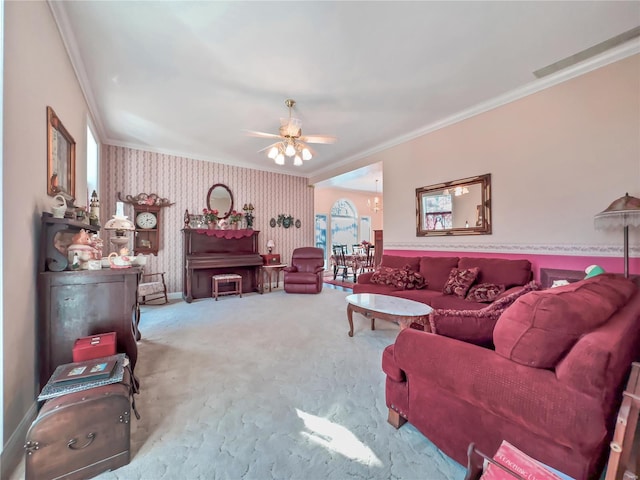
458, 257, 531, 288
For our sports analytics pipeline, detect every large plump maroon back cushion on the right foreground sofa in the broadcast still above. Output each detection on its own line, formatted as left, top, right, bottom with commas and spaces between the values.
493, 274, 636, 368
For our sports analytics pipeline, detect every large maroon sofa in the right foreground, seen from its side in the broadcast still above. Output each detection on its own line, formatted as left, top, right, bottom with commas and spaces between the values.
382, 274, 640, 480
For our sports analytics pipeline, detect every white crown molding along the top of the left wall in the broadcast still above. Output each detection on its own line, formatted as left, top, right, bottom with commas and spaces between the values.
47, 0, 107, 143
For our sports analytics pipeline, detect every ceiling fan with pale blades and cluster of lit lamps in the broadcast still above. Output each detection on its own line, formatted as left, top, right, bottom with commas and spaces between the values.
247, 98, 337, 166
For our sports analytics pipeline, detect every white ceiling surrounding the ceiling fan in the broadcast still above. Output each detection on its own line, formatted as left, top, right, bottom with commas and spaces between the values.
50, 1, 640, 190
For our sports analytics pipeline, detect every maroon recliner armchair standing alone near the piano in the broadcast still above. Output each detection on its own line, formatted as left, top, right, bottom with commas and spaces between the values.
284, 247, 324, 293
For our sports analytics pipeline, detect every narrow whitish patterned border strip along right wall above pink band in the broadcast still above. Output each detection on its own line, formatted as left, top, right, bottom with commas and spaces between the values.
384, 241, 640, 258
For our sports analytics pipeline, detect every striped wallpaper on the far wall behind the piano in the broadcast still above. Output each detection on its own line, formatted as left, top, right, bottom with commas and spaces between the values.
98, 145, 314, 292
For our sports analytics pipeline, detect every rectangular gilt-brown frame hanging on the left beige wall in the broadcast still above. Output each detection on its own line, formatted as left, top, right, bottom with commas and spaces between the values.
47, 107, 76, 199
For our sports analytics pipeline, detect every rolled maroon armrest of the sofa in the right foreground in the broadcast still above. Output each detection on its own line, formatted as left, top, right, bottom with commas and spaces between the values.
393, 328, 606, 442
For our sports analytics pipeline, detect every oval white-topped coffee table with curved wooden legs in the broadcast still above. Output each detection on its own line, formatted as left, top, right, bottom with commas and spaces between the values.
346, 293, 433, 337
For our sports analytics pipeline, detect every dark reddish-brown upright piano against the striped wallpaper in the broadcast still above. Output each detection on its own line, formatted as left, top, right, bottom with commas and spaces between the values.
182, 228, 262, 303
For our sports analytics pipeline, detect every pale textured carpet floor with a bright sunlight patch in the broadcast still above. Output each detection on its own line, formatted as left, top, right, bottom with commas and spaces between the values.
12, 288, 465, 480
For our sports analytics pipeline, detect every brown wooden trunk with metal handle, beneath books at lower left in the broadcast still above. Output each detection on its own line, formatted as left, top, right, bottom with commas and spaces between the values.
25, 372, 131, 480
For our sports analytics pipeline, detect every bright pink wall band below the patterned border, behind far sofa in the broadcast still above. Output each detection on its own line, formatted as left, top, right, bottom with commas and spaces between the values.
384, 249, 640, 280
